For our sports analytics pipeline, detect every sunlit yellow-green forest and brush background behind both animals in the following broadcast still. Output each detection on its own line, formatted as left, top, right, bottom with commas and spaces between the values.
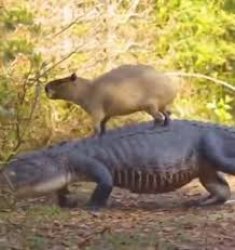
0, 0, 235, 161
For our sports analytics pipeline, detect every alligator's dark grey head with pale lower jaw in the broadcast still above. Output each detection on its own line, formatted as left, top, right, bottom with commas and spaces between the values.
0, 155, 72, 197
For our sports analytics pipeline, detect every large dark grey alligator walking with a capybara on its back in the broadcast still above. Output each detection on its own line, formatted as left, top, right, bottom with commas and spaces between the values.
0, 120, 235, 208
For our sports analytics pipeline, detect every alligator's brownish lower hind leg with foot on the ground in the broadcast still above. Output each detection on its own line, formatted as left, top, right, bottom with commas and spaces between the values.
198, 168, 231, 206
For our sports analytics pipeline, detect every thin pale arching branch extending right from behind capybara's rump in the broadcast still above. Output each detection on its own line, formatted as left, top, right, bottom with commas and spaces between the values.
166, 72, 235, 92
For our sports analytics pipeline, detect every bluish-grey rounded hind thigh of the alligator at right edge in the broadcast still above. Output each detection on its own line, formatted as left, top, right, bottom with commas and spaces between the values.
199, 132, 235, 175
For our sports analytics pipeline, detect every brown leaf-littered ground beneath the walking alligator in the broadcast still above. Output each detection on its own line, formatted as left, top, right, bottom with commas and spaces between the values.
0, 177, 235, 250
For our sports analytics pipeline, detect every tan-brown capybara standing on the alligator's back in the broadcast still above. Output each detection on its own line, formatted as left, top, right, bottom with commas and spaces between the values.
45, 65, 180, 134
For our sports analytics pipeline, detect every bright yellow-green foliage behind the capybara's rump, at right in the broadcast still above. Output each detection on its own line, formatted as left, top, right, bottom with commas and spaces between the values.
155, 1, 235, 123
